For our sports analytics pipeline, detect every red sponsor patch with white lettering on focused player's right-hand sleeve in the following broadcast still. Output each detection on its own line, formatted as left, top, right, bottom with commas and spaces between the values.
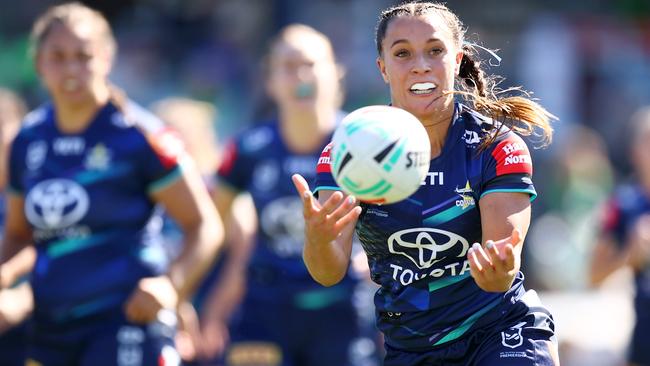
492, 136, 533, 176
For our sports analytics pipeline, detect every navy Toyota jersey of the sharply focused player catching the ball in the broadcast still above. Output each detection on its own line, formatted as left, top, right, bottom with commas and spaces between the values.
315, 104, 536, 350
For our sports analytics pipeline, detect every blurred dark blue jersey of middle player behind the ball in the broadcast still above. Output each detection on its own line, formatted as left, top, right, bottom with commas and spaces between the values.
218, 122, 349, 308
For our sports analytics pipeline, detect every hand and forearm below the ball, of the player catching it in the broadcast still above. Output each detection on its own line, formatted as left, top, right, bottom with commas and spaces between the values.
292, 174, 361, 286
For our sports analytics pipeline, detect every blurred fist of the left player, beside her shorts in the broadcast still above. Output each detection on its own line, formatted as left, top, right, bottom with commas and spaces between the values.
125, 275, 178, 324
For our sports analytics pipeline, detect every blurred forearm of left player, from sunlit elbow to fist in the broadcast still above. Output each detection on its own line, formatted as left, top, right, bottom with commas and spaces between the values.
168, 223, 223, 300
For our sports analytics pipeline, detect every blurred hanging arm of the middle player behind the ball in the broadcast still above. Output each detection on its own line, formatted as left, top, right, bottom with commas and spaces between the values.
201, 184, 257, 357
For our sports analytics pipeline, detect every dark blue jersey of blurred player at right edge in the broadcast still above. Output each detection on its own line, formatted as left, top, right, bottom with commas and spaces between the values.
602, 184, 650, 318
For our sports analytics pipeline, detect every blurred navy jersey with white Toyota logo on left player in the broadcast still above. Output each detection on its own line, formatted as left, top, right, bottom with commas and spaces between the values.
9, 99, 183, 324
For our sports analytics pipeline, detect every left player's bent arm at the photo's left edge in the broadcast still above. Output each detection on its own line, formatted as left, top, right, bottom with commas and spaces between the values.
0, 193, 36, 288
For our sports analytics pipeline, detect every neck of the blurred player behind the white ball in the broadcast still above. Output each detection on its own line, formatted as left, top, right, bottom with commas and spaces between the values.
280, 109, 336, 153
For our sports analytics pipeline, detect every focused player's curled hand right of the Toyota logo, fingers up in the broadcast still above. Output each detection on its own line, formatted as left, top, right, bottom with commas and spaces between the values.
467, 229, 523, 292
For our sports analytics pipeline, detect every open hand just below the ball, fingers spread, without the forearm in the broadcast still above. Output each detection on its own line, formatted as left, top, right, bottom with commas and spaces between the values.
291, 174, 361, 245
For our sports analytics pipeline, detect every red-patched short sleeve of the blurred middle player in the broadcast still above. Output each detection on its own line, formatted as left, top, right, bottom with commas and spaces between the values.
217, 138, 253, 191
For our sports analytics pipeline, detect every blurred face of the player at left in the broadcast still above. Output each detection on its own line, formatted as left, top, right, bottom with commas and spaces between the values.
36, 21, 111, 104
